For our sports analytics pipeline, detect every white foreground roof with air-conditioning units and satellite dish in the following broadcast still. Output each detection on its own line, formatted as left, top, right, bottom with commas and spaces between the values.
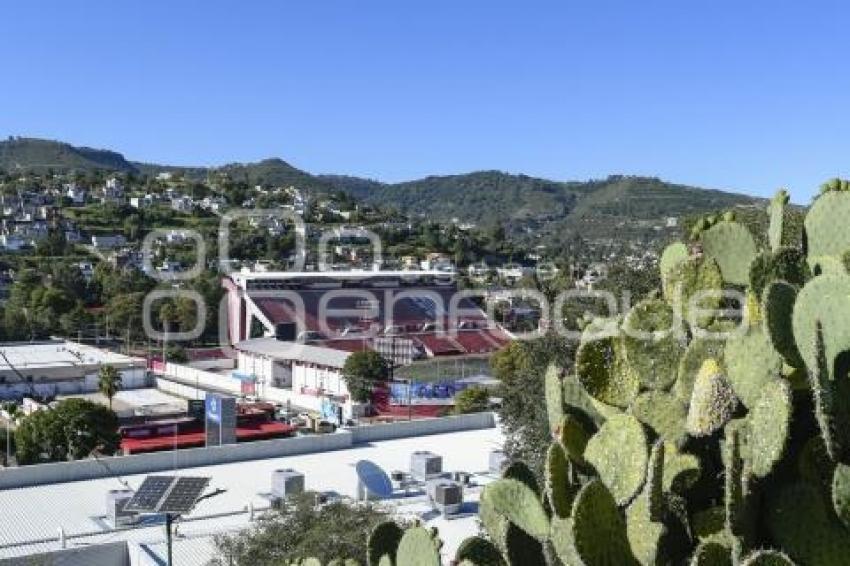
0, 428, 503, 566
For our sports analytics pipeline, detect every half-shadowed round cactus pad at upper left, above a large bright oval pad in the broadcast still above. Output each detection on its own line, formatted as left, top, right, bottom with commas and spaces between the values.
576, 337, 640, 408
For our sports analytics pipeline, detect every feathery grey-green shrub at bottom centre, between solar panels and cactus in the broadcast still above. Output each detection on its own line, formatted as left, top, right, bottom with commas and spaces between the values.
213, 493, 391, 566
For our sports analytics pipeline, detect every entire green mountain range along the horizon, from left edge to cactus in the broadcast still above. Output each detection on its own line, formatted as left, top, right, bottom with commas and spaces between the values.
0, 137, 763, 233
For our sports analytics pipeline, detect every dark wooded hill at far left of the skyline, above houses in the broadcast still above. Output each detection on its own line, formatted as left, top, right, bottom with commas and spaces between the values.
0, 137, 136, 173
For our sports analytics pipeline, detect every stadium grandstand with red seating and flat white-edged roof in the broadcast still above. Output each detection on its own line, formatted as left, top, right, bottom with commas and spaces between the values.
223, 271, 510, 358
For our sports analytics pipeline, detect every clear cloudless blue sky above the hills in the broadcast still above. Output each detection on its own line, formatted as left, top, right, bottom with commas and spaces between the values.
0, 0, 850, 202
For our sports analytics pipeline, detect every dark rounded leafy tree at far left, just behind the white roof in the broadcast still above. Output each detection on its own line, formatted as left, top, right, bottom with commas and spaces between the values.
15, 398, 121, 465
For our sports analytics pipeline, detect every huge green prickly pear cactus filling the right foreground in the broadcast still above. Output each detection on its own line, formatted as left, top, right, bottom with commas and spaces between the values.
444, 181, 850, 566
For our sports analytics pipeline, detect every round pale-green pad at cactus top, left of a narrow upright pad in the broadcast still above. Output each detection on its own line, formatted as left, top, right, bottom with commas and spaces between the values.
700, 222, 756, 285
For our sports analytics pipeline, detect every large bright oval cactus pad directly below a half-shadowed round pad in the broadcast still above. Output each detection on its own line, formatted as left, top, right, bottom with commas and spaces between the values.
584, 415, 649, 505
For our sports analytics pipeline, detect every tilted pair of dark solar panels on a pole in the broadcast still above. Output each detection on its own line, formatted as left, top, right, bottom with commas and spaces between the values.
124, 476, 210, 515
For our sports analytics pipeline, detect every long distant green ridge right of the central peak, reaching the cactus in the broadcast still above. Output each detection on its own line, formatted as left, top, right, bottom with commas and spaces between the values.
324, 171, 759, 231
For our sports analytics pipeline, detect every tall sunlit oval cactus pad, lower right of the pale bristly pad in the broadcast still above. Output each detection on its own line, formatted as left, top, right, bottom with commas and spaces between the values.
747, 381, 793, 478
